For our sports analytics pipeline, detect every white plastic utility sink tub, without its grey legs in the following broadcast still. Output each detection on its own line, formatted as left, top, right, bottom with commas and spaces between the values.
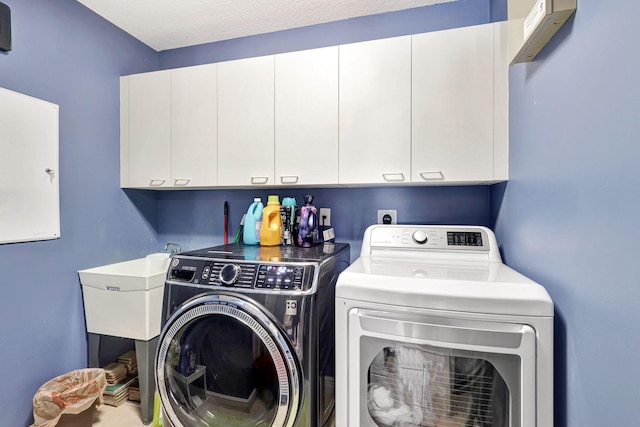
78, 253, 171, 341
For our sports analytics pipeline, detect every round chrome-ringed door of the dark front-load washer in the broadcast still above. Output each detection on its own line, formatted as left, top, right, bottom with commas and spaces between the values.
156, 292, 301, 427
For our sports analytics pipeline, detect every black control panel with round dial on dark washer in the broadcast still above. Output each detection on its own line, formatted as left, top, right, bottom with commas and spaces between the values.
167, 257, 314, 291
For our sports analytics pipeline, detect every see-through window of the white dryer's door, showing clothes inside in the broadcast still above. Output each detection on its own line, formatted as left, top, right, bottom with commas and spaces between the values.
367, 345, 509, 427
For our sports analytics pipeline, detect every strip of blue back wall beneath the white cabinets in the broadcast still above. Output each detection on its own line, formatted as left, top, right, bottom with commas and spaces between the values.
158, 186, 490, 260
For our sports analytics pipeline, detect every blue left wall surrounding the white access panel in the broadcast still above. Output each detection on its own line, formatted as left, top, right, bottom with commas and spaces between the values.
0, 0, 159, 427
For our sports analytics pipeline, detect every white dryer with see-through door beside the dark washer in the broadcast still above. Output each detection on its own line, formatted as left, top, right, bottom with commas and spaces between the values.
336, 225, 554, 427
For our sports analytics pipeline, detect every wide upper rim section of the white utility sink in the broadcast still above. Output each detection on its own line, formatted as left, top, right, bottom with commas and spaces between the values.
78, 253, 170, 291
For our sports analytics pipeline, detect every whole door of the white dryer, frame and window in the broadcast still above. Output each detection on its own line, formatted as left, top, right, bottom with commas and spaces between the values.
348, 310, 536, 427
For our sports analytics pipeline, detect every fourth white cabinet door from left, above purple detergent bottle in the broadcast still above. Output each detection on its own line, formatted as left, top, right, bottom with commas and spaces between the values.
275, 46, 338, 185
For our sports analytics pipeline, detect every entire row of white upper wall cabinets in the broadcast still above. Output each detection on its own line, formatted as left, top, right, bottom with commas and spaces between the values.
120, 22, 509, 189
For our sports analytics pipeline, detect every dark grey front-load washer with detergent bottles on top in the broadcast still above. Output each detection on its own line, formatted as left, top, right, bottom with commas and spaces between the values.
155, 243, 350, 427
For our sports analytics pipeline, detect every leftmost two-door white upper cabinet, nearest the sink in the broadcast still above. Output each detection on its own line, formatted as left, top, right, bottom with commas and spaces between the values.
120, 64, 218, 188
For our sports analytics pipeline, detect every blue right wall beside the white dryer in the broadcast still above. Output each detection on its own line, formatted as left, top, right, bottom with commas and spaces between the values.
492, 0, 640, 427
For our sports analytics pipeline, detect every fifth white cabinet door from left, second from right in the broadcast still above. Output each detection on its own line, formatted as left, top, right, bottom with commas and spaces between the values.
339, 36, 411, 184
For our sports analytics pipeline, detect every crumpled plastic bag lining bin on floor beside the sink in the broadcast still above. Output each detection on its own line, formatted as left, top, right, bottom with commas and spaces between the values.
33, 368, 107, 427
